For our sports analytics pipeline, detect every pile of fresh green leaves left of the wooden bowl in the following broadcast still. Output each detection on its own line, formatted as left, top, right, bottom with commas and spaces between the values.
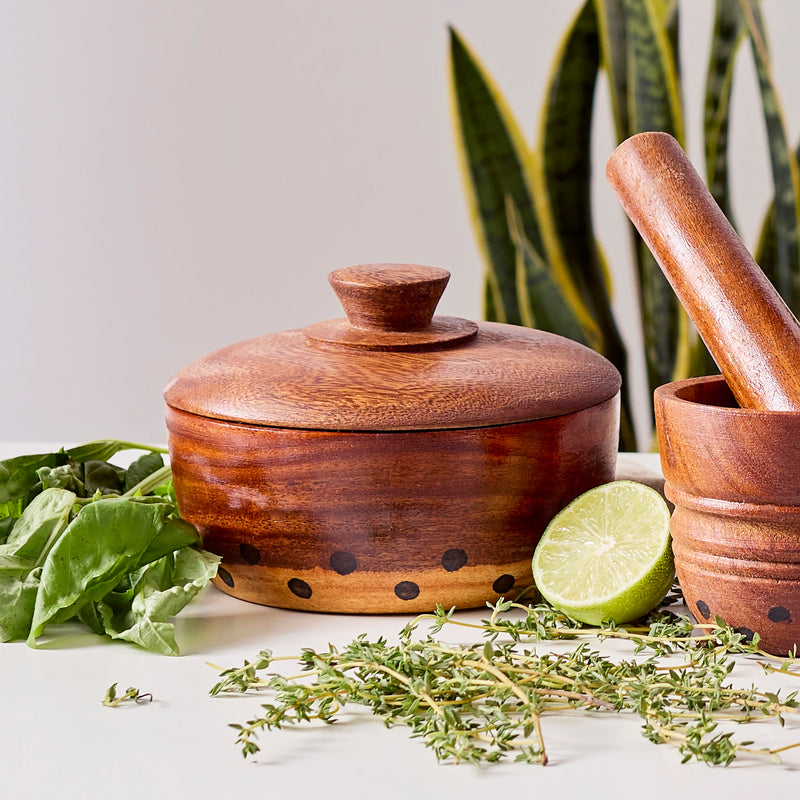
0, 440, 219, 655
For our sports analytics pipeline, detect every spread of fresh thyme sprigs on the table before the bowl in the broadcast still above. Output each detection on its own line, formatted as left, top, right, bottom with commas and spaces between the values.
211, 600, 800, 765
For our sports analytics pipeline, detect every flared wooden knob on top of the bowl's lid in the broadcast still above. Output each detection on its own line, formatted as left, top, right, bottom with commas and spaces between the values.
328, 264, 450, 331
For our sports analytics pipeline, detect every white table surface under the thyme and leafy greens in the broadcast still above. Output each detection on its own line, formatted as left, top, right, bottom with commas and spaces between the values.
0, 443, 800, 800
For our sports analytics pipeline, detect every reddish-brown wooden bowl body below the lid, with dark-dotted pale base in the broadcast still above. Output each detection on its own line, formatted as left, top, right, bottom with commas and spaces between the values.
166, 395, 619, 613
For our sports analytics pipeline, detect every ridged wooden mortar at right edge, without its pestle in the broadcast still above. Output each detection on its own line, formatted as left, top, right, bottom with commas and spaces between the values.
655, 377, 800, 655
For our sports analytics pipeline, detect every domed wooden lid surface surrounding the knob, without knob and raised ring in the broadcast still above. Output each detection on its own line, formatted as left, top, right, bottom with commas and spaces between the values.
165, 322, 621, 431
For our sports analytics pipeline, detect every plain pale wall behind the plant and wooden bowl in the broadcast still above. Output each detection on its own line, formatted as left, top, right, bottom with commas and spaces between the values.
0, 0, 800, 441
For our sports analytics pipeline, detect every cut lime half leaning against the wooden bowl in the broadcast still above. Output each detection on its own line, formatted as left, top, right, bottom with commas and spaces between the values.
533, 481, 675, 625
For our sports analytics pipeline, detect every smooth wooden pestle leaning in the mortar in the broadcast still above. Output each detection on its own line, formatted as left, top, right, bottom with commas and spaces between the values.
606, 133, 800, 411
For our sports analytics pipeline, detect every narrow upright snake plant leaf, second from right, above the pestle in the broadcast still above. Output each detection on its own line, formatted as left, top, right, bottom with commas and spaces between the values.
703, 0, 746, 227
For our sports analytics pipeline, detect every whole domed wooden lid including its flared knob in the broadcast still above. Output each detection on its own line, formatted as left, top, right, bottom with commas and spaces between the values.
164, 264, 621, 431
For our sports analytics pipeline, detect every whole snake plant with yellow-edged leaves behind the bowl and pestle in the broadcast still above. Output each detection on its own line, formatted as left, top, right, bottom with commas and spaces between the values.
450, 0, 800, 450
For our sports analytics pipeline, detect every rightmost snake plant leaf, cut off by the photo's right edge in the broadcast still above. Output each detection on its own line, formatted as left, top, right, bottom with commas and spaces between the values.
740, 0, 800, 312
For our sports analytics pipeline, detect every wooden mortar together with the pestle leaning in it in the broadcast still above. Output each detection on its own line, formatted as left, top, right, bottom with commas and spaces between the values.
606, 133, 800, 654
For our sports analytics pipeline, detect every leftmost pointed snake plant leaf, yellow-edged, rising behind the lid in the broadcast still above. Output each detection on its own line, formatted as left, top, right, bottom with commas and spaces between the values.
450, 28, 542, 324
